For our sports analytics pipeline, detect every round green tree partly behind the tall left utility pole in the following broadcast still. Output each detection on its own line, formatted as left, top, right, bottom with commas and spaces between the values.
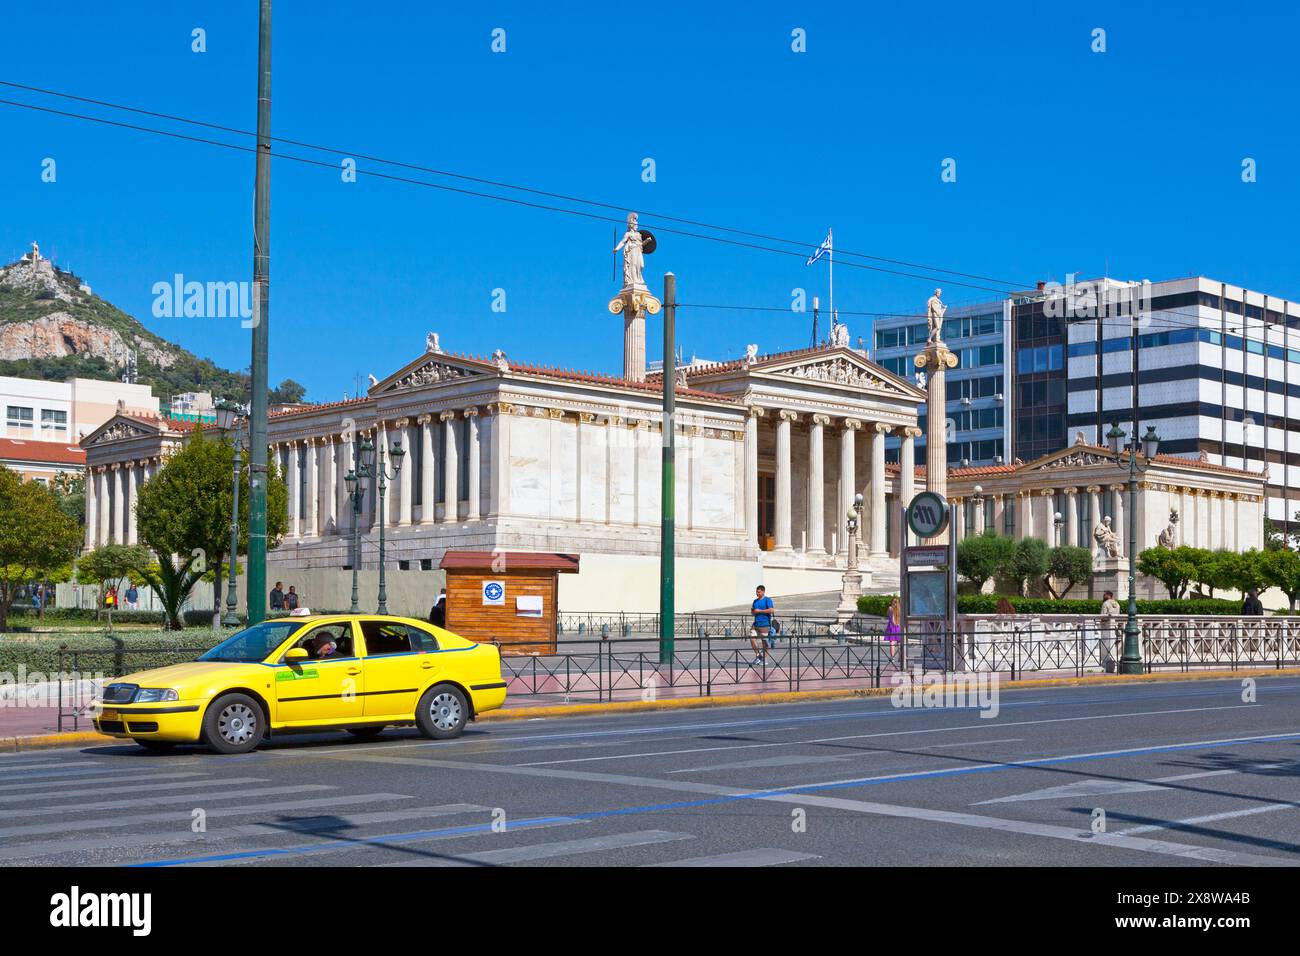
135, 428, 289, 624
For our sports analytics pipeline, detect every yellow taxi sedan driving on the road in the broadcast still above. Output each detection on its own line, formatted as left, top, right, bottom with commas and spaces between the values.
95, 611, 506, 753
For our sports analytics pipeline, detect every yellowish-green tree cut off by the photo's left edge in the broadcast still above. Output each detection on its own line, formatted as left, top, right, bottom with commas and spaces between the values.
0, 467, 81, 631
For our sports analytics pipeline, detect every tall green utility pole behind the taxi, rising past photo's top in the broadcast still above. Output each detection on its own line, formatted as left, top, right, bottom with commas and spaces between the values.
246, 0, 270, 626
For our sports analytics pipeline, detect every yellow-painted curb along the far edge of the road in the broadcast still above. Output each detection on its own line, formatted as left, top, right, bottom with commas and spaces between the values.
0, 667, 1300, 753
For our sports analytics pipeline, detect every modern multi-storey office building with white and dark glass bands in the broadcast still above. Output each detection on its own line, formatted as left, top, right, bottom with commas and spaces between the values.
872, 276, 1300, 529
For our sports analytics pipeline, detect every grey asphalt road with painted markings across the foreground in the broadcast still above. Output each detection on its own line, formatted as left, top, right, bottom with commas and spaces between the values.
0, 678, 1300, 866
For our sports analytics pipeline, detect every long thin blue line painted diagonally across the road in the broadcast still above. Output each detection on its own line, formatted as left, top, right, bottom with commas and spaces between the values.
129, 734, 1300, 868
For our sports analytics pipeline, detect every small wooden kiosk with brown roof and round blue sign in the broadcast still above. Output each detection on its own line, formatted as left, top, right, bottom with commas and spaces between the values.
441, 551, 579, 654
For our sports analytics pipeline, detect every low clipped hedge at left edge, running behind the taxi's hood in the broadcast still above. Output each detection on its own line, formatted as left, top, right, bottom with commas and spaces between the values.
0, 628, 229, 680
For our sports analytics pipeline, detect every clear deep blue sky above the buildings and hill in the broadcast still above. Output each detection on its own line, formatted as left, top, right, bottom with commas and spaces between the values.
0, 0, 1300, 401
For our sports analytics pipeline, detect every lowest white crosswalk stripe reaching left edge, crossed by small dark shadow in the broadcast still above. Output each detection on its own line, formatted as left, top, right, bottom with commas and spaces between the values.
0, 795, 490, 860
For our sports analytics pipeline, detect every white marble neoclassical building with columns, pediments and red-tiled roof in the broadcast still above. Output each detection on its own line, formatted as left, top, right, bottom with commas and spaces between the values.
82, 337, 1264, 610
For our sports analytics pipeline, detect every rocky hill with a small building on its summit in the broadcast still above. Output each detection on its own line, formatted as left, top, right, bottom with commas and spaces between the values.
0, 248, 248, 403
